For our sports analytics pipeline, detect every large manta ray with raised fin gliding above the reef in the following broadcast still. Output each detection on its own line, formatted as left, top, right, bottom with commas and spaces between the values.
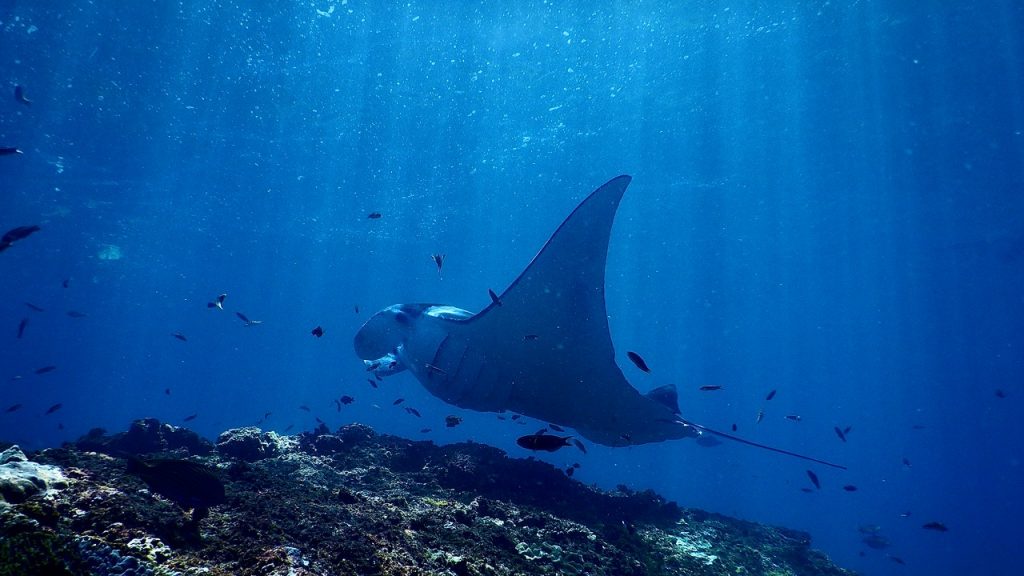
355, 175, 842, 467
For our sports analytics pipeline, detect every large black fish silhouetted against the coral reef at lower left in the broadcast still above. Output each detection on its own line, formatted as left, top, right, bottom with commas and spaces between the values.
128, 457, 224, 508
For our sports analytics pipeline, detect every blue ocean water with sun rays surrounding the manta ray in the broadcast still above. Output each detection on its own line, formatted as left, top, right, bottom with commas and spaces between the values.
0, 0, 1024, 575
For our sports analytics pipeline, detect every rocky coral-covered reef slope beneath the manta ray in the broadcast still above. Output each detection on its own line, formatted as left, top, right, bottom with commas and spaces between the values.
0, 420, 850, 576
